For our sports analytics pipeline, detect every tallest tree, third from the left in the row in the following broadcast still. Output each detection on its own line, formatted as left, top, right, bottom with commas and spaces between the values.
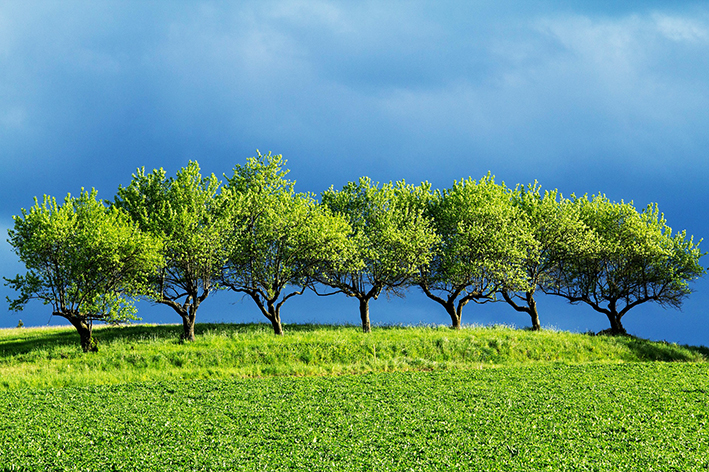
220, 153, 350, 335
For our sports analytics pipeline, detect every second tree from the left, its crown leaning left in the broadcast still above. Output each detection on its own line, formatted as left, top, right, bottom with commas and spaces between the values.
114, 161, 227, 341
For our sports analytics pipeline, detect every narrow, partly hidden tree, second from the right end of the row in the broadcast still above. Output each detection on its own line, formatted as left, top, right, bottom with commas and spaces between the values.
500, 182, 595, 331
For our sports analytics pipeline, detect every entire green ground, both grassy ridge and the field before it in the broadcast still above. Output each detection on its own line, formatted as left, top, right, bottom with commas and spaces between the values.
0, 325, 709, 471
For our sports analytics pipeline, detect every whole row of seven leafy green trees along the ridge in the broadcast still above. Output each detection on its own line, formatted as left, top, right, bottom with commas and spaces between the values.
6, 153, 705, 351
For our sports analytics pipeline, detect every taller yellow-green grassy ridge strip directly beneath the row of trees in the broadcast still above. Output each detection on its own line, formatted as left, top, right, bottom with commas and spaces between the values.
0, 324, 709, 389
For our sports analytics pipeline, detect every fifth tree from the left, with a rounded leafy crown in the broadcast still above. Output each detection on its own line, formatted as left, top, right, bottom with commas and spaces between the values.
418, 174, 535, 329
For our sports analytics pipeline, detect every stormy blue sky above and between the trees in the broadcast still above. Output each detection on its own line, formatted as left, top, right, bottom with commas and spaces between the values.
0, 0, 709, 345
